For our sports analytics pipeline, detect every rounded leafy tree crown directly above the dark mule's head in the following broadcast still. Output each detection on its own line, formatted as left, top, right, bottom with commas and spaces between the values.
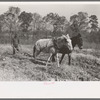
70, 12, 89, 34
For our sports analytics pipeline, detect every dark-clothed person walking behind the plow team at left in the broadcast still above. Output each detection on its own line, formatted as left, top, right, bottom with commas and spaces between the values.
11, 34, 19, 54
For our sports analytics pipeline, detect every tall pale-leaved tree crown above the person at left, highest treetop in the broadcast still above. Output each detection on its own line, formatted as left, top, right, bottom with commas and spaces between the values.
4, 7, 20, 33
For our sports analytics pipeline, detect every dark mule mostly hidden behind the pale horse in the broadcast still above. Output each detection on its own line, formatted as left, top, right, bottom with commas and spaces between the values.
52, 34, 83, 65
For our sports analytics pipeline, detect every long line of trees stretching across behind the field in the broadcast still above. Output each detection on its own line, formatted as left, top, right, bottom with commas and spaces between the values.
0, 7, 100, 43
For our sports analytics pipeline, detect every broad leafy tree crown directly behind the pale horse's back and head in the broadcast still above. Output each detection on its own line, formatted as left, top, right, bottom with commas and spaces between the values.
43, 13, 68, 36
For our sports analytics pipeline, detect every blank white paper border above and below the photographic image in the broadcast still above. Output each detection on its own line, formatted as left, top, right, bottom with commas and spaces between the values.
0, 1, 100, 98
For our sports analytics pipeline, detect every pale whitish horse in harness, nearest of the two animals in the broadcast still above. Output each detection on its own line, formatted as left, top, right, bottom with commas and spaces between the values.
33, 34, 73, 67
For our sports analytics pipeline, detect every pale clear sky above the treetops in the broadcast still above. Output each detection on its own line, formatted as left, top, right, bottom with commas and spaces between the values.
0, 2, 100, 24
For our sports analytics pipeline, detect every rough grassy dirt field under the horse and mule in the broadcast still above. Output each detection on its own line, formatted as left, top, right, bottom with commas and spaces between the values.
0, 45, 100, 81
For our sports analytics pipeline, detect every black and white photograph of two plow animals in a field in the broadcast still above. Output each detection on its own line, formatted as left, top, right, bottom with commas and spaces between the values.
0, 2, 100, 82
